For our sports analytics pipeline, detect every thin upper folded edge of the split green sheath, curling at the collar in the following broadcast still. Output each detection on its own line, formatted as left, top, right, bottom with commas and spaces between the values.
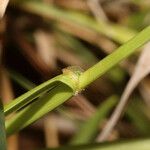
4, 74, 76, 115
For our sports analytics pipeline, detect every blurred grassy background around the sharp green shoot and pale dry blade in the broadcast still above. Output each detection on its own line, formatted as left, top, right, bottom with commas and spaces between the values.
0, 0, 150, 150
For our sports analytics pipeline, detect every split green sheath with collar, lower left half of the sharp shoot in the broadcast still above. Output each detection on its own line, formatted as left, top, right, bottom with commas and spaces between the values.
5, 66, 81, 136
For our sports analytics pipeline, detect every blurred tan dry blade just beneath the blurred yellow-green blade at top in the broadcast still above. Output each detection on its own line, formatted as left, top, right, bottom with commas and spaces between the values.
58, 21, 116, 53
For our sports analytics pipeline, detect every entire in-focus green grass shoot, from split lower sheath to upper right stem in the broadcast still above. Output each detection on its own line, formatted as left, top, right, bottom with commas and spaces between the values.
5, 26, 150, 135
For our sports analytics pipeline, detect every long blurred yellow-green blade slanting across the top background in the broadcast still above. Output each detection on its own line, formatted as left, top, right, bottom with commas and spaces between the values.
20, 1, 136, 43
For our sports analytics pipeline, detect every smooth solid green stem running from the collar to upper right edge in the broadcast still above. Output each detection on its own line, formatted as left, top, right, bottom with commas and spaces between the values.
79, 26, 150, 90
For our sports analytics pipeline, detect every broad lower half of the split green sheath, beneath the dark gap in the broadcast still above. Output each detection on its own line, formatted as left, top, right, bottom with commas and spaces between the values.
6, 83, 74, 136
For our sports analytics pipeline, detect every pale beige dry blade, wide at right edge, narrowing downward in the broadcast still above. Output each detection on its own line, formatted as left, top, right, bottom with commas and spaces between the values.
98, 42, 150, 141
